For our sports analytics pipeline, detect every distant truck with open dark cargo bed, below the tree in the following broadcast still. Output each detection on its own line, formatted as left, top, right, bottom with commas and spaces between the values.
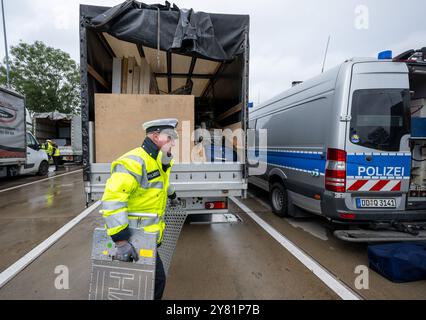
33, 111, 83, 163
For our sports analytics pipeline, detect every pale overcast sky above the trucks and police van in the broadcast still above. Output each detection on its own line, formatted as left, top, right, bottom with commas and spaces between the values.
0, 0, 426, 104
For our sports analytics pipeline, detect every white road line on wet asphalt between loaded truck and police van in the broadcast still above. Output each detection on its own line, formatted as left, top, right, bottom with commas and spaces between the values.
230, 197, 362, 300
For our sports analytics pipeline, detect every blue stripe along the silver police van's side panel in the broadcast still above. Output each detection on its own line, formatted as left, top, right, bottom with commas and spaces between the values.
248, 150, 326, 174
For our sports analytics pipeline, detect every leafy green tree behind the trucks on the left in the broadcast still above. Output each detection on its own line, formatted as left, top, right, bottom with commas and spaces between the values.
0, 41, 80, 114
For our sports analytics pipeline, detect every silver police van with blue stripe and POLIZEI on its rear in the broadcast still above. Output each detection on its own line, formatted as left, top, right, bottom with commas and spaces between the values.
249, 50, 426, 241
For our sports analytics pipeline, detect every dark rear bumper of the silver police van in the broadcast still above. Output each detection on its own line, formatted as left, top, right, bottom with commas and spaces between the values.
321, 194, 426, 224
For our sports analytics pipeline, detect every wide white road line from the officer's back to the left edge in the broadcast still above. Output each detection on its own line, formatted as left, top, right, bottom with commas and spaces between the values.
0, 201, 101, 288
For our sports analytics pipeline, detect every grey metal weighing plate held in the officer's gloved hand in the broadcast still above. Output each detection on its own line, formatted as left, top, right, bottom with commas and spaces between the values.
89, 229, 157, 300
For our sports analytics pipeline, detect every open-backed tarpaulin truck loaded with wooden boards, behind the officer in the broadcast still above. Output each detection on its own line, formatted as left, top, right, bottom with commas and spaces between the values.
80, 1, 249, 214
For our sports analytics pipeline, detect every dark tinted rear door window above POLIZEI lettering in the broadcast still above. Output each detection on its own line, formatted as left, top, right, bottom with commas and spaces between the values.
349, 89, 410, 151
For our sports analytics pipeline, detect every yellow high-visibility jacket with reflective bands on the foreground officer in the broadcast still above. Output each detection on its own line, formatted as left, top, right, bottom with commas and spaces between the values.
101, 138, 174, 244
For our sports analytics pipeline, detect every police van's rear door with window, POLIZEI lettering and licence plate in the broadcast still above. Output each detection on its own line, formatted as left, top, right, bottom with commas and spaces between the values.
346, 61, 411, 210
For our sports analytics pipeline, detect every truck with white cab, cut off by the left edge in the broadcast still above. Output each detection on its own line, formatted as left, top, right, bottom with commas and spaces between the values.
0, 87, 49, 177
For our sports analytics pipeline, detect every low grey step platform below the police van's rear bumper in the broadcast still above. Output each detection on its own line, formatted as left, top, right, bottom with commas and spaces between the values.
334, 230, 426, 243
